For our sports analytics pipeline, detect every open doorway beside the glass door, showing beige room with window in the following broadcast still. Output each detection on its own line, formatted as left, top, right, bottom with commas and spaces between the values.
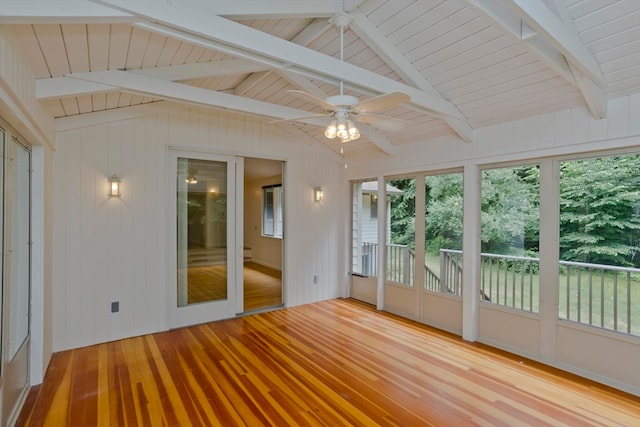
243, 157, 284, 313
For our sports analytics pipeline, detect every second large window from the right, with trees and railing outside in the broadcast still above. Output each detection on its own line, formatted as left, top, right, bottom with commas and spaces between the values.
480, 165, 540, 313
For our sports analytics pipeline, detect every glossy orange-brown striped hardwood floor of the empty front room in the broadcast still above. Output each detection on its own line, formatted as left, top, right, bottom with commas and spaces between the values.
18, 299, 640, 426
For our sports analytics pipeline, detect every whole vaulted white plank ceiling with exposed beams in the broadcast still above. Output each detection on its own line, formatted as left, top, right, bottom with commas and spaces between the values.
0, 0, 640, 154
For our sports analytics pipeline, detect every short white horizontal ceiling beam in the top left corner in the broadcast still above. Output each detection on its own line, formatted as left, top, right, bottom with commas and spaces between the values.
0, 0, 138, 24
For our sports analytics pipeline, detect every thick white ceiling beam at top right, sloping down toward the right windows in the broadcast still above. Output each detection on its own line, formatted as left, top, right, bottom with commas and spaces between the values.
466, 0, 607, 119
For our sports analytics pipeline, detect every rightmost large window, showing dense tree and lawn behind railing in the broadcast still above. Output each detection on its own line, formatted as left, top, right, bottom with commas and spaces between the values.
558, 154, 640, 336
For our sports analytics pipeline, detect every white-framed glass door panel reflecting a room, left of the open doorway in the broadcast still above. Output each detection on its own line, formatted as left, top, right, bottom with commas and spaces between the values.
169, 150, 241, 327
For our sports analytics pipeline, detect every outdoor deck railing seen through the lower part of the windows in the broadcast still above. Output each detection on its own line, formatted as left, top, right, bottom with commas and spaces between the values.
363, 243, 640, 336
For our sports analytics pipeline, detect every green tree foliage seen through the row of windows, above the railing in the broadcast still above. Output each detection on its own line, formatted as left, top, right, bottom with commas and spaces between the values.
382, 155, 640, 267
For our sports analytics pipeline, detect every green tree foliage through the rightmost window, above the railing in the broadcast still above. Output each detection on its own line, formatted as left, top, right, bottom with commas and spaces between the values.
560, 155, 640, 267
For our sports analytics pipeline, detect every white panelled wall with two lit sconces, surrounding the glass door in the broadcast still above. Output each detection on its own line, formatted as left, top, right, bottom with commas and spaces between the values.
53, 107, 347, 351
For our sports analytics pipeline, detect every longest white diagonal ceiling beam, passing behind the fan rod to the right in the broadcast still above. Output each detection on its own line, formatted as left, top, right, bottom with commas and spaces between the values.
96, 0, 473, 141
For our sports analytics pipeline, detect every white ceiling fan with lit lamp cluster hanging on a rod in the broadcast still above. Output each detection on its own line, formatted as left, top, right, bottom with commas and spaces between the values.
276, 13, 411, 143
